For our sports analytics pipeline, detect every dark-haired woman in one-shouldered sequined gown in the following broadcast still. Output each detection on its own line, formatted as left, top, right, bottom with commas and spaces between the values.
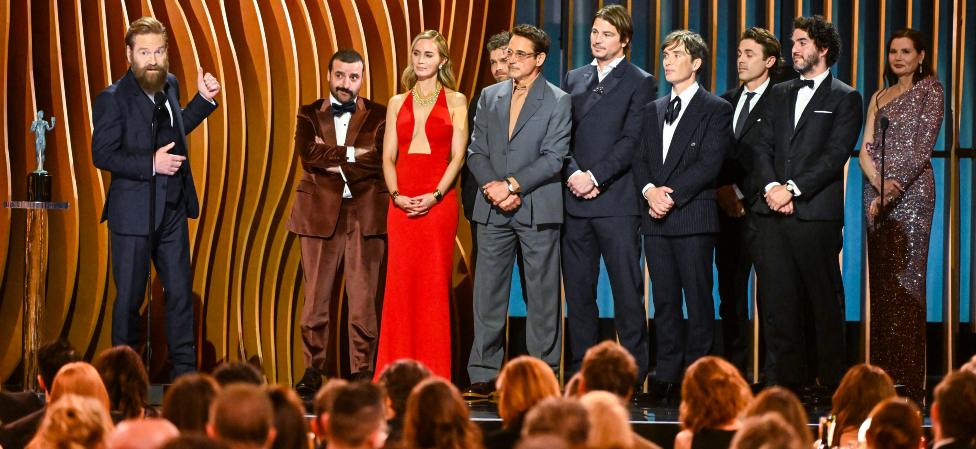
859, 29, 944, 403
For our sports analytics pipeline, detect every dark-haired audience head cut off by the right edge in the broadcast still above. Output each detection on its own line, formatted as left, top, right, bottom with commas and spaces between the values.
931, 370, 976, 449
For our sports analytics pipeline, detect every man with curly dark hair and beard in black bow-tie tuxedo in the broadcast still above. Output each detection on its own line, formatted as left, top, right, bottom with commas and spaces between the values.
753, 16, 863, 395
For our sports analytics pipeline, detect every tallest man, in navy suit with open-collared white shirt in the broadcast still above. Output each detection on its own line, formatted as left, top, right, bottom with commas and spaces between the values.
562, 5, 657, 385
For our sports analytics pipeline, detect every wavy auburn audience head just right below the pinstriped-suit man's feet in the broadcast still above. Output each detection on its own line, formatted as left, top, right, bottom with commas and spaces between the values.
678, 356, 752, 433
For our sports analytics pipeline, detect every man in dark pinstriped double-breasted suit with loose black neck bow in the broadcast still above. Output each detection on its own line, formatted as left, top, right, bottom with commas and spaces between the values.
634, 30, 732, 402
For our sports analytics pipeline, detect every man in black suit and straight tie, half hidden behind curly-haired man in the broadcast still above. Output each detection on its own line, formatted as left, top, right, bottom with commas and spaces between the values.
715, 27, 780, 374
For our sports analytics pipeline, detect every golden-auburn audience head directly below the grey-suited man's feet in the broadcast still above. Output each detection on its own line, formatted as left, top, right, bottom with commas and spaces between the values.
497, 355, 559, 427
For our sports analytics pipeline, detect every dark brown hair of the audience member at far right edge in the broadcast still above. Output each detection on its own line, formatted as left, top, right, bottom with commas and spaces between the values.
933, 371, 976, 441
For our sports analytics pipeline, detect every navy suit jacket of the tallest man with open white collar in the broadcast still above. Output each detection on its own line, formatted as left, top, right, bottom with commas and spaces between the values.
562, 59, 657, 217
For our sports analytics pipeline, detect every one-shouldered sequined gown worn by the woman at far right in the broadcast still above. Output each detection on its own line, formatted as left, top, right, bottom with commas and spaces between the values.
863, 77, 944, 402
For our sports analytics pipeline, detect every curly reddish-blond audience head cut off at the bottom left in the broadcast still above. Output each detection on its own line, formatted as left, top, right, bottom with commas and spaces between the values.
27, 393, 112, 449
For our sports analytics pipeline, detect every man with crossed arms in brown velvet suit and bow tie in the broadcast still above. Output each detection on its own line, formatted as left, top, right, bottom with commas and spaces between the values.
288, 50, 388, 398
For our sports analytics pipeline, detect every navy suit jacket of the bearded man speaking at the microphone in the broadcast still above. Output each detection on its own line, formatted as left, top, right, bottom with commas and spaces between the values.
92, 70, 217, 235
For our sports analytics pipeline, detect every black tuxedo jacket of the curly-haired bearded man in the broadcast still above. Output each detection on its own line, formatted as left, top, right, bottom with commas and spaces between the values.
753, 75, 864, 221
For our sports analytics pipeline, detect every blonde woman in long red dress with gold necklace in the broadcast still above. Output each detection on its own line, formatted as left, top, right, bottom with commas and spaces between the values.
376, 30, 468, 379
